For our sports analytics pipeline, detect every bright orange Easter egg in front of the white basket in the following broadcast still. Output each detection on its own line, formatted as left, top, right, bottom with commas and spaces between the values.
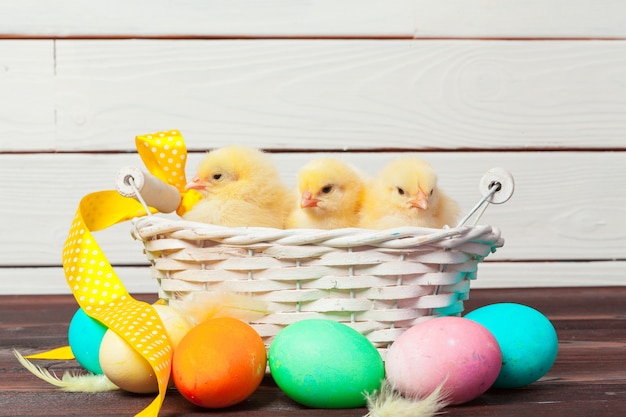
172, 317, 267, 408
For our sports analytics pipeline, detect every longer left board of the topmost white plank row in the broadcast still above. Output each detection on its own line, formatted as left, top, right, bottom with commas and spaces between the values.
0, 0, 414, 38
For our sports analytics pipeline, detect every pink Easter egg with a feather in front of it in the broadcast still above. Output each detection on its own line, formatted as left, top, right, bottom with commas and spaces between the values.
385, 317, 502, 404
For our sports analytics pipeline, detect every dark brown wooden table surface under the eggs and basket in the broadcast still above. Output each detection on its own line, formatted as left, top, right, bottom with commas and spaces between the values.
0, 287, 626, 417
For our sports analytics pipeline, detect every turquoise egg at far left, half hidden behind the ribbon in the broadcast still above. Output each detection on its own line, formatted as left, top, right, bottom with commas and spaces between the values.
67, 308, 107, 374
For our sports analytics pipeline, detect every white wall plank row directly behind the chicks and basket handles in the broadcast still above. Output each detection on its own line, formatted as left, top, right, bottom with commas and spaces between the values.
0, 150, 626, 266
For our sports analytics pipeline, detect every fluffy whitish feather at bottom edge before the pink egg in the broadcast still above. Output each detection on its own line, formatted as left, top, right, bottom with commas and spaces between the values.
365, 380, 449, 417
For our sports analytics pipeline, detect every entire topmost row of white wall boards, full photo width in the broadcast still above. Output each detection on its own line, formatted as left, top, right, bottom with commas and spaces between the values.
0, 0, 626, 39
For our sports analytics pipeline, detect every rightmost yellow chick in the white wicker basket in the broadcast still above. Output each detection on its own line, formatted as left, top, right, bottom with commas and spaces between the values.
359, 157, 460, 229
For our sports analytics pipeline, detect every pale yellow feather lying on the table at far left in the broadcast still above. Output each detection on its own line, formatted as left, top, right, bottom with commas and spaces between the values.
13, 350, 119, 392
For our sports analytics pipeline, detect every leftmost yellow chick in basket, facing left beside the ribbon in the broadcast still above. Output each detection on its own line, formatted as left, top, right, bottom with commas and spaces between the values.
183, 145, 290, 228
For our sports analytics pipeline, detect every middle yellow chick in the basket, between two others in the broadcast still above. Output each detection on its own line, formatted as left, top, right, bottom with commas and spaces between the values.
285, 158, 364, 229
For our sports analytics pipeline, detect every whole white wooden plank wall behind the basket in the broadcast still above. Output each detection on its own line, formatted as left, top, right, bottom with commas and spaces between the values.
0, 0, 626, 294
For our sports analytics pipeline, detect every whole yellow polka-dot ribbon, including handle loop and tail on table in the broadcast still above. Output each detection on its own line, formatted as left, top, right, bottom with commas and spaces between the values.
29, 131, 195, 417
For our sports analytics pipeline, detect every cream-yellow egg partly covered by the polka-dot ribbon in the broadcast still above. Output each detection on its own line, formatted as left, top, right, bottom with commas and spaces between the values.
99, 304, 192, 394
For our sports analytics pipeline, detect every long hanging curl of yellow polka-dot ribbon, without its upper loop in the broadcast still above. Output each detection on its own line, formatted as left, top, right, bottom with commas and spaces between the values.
63, 191, 172, 416
